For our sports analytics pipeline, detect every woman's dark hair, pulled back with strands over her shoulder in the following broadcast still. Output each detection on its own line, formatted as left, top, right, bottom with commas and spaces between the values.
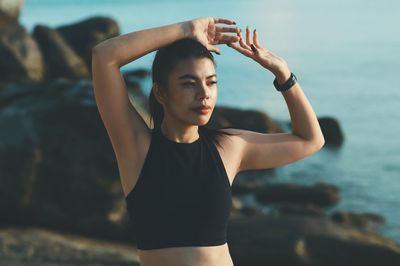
149, 38, 235, 150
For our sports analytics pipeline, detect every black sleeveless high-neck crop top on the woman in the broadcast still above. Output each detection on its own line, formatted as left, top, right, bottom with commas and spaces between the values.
125, 127, 232, 250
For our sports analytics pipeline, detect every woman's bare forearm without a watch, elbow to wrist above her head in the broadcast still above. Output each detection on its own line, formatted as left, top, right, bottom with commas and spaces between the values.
92, 21, 191, 67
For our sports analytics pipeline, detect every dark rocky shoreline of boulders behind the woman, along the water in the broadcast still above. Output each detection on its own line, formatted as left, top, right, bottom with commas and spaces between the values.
0, 2, 400, 266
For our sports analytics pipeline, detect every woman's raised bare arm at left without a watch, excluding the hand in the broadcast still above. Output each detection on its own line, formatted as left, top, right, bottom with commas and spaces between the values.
92, 19, 197, 194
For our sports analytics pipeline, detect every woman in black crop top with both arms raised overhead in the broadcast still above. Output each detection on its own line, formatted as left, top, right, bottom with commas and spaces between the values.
92, 17, 324, 266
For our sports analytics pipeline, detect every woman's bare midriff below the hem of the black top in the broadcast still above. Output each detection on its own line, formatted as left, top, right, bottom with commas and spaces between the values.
138, 243, 233, 266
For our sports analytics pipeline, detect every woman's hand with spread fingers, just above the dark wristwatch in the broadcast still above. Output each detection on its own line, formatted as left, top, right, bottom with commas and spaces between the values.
226, 26, 288, 74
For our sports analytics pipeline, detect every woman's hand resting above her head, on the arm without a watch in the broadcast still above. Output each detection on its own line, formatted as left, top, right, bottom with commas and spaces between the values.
188, 17, 240, 54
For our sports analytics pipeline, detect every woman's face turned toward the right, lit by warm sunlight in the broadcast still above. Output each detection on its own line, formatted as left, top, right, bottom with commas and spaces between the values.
158, 58, 218, 125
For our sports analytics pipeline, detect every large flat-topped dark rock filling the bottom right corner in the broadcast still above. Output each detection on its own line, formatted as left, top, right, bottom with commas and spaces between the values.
228, 215, 400, 266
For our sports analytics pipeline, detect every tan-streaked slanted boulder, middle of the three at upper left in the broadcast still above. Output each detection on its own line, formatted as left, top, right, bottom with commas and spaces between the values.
33, 25, 91, 79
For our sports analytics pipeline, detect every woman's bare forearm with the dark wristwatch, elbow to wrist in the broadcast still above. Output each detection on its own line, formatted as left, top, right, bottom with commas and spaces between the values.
276, 69, 325, 146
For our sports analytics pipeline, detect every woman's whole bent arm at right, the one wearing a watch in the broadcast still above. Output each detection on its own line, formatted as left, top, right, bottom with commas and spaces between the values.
227, 27, 325, 172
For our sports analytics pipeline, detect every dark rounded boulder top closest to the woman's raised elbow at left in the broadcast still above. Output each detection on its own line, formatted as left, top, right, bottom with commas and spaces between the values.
56, 16, 120, 72
